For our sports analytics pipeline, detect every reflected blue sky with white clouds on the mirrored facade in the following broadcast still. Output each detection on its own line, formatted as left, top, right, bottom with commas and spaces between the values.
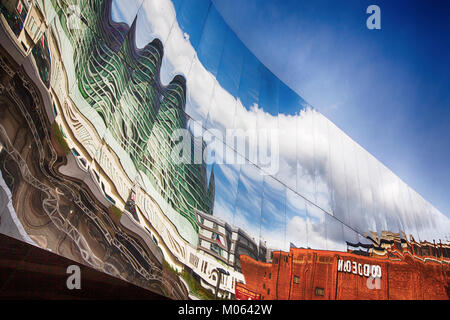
146, 0, 450, 251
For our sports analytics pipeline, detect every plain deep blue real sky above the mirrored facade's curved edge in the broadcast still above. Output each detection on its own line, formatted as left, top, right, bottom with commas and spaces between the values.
213, 0, 450, 216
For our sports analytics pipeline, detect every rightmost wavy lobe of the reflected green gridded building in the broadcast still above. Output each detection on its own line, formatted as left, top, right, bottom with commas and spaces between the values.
144, 75, 212, 225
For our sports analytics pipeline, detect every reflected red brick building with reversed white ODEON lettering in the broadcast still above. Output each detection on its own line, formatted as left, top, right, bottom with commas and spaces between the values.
236, 242, 450, 300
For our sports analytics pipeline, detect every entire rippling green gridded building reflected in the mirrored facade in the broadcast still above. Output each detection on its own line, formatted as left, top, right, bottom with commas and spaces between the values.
53, 1, 213, 230
